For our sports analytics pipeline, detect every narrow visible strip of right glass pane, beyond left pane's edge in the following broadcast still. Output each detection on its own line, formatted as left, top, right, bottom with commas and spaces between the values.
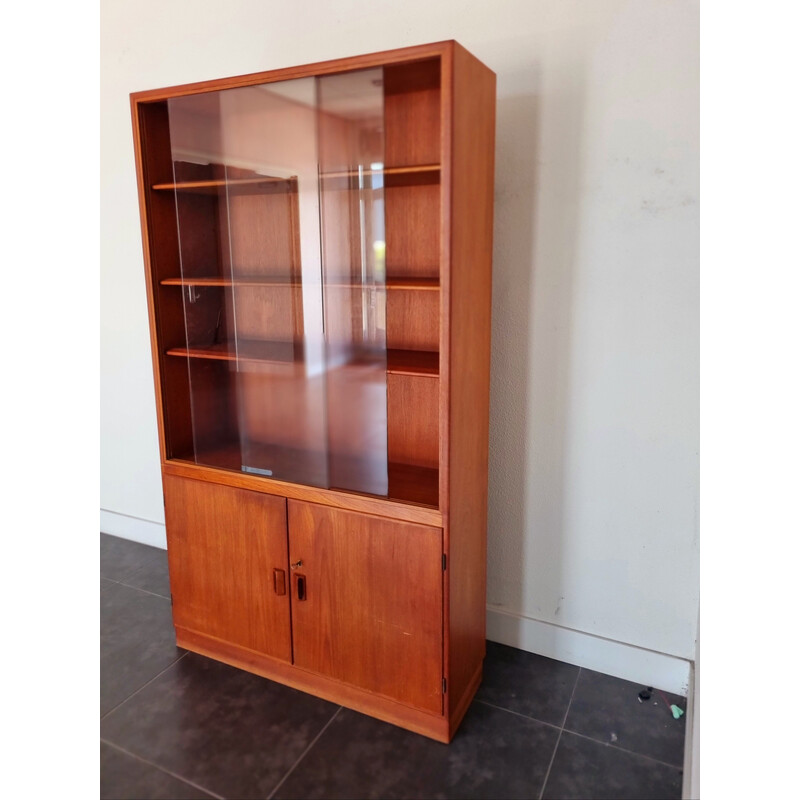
317, 69, 388, 495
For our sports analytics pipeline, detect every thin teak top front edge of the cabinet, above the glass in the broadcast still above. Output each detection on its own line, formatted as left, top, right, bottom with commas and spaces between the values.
131, 39, 488, 104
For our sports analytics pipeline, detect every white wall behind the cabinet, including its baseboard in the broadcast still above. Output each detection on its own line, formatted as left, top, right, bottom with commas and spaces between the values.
101, 0, 699, 689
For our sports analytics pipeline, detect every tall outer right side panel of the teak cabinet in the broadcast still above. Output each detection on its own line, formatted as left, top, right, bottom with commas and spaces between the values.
447, 44, 495, 713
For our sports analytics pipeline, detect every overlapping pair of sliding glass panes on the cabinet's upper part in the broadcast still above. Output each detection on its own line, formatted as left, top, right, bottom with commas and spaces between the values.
164, 70, 388, 495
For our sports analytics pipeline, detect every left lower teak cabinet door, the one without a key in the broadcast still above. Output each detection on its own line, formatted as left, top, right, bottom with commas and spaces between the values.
164, 475, 292, 661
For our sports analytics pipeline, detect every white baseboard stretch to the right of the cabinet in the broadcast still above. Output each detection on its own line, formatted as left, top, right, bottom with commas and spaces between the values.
486, 606, 691, 697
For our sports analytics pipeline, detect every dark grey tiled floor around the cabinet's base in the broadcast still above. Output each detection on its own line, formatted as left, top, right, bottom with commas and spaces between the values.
100, 534, 686, 800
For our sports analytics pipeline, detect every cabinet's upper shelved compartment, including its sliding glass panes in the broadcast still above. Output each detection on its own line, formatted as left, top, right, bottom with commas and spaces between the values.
139, 57, 442, 508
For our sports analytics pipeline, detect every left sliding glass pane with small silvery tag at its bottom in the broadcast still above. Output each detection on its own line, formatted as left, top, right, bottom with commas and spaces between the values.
169, 78, 328, 486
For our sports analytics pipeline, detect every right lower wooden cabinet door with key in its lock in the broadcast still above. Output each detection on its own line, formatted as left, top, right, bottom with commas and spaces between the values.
288, 500, 443, 713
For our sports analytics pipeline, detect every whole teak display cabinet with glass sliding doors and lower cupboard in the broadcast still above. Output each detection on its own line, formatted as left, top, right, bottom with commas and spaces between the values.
131, 42, 495, 741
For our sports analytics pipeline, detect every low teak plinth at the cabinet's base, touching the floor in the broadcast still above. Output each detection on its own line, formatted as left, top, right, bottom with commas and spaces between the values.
175, 626, 481, 744
